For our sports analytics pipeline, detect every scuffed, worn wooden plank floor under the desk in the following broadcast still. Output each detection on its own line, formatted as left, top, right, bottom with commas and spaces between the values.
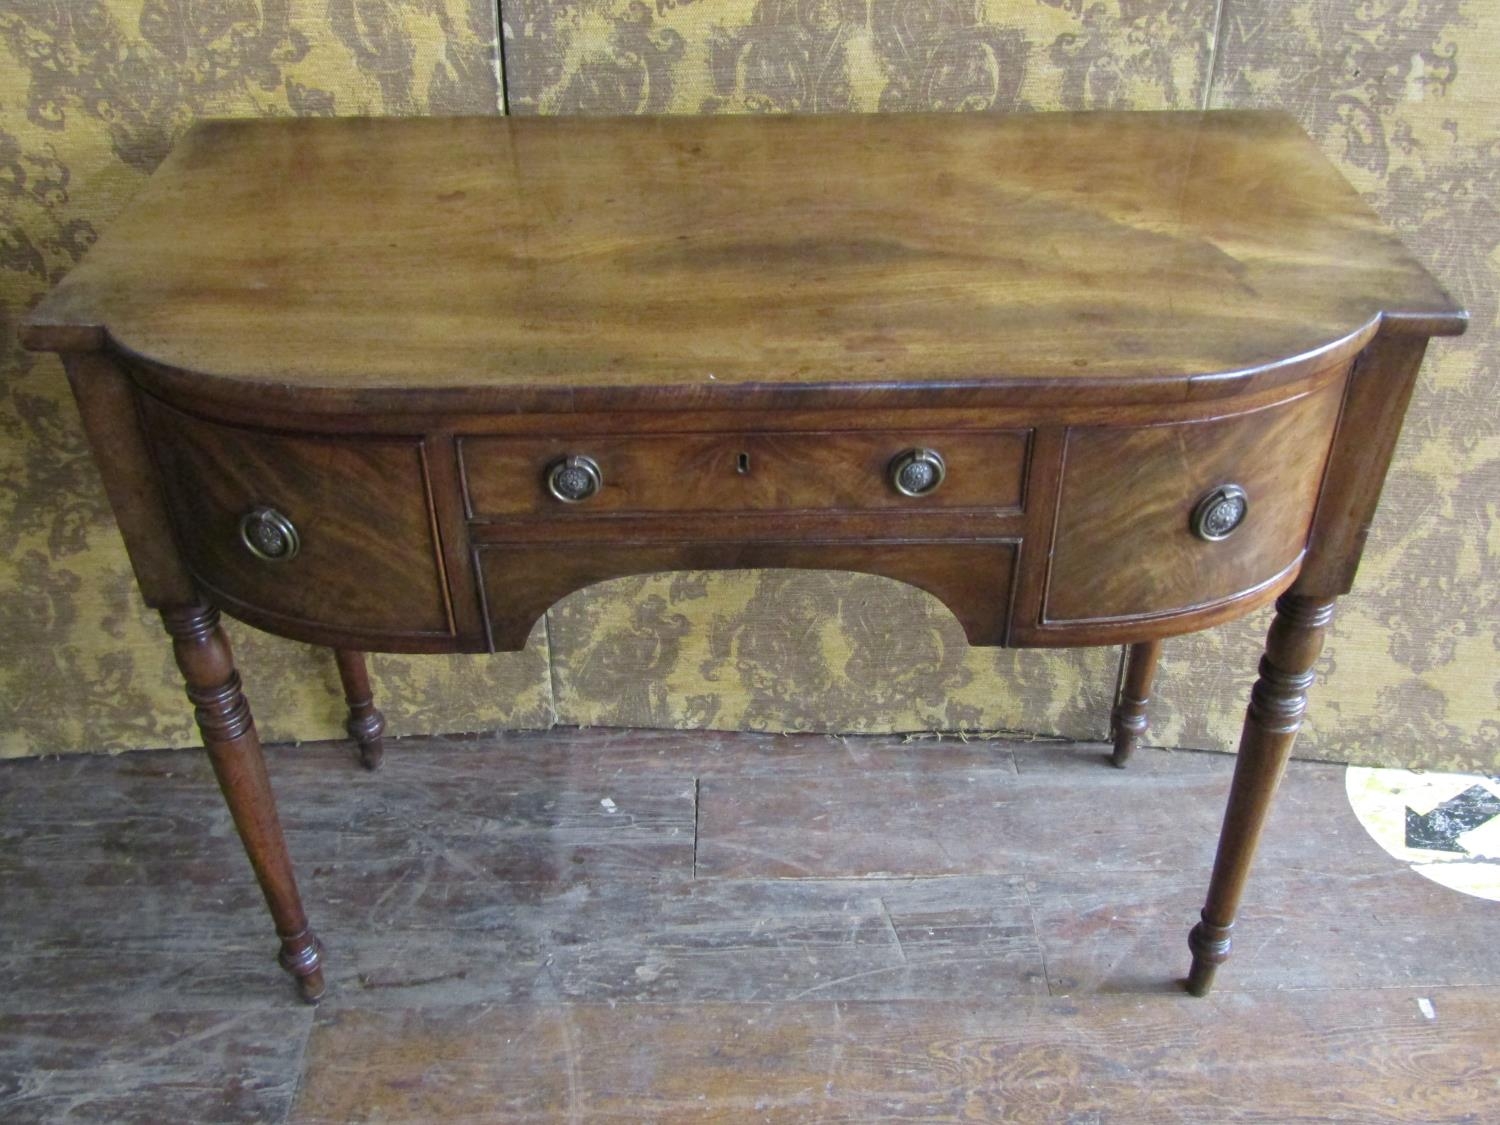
0, 731, 1500, 1122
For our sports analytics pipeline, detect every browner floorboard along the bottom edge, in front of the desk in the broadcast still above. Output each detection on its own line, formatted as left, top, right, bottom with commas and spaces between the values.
293, 989, 1500, 1125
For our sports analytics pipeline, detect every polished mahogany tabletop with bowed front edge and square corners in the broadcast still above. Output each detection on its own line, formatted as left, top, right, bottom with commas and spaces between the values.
23, 111, 1464, 407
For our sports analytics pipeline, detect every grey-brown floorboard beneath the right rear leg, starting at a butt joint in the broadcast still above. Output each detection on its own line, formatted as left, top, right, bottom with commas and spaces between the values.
696, 746, 1389, 879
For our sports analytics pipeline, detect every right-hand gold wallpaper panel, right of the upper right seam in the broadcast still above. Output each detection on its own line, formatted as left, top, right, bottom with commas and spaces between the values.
1164, 0, 1500, 770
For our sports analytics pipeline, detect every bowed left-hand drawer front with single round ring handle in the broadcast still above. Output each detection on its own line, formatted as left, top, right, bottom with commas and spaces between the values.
141, 398, 453, 639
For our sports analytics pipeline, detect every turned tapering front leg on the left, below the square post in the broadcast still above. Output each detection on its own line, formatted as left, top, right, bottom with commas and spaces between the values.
162, 605, 323, 1004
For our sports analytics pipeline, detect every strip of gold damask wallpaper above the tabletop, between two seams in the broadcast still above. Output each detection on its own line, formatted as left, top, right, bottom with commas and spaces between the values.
501, 0, 1215, 113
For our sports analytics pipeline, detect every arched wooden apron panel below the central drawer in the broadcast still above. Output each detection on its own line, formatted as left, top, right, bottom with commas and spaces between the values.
476, 540, 1019, 651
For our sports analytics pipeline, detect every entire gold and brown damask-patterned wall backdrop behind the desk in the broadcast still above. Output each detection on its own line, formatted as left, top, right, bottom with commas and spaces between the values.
0, 0, 1500, 771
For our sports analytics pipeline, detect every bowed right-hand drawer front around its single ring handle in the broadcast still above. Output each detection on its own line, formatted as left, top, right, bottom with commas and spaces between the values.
1044, 381, 1343, 624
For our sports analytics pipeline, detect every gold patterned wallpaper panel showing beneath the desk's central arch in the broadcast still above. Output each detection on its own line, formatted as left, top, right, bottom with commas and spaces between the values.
549, 570, 1118, 738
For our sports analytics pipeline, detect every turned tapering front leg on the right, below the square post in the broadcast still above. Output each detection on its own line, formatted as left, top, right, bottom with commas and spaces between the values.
1188, 594, 1334, 996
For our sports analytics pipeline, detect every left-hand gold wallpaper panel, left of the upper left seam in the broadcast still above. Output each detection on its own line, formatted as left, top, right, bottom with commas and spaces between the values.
0, 0, 551, 755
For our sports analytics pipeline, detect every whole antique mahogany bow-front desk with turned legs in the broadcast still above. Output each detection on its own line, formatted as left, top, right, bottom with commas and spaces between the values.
24, 111, 1466, 1001
